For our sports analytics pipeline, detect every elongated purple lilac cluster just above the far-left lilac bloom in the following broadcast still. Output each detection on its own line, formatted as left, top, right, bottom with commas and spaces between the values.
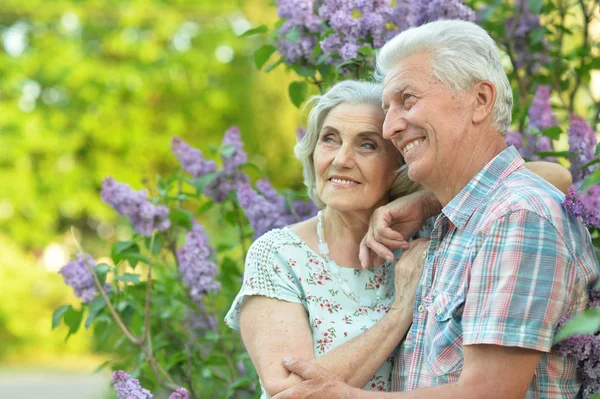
100, 177, 171, 237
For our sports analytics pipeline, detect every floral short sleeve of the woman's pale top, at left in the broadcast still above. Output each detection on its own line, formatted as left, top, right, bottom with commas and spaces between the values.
225, 232, 302, 330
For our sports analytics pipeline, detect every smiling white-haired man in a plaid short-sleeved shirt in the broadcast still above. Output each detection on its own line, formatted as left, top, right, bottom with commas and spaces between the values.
275, 21, 599, 399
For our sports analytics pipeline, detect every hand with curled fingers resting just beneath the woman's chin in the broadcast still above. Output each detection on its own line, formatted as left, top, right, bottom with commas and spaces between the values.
359, 191, 441, 269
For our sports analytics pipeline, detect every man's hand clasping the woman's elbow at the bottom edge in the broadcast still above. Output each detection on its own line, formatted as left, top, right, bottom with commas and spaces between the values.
273, 358, 353, 399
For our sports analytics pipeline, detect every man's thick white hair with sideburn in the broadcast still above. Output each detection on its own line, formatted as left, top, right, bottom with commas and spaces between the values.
377, 20, 513, 134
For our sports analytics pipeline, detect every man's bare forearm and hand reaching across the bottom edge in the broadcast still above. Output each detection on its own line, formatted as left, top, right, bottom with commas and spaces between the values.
273, 345, 542, 399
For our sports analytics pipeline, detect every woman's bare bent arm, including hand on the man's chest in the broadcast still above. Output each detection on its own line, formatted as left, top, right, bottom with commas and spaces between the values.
240, 240, 428, 396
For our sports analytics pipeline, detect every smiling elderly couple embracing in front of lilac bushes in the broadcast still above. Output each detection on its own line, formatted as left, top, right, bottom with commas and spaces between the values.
226, 21, 599, 399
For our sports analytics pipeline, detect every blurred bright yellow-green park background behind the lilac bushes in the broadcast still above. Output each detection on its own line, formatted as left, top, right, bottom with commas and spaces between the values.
0, 0, 600, 398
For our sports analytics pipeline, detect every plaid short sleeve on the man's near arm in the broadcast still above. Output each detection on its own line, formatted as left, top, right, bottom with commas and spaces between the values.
462, 210, 576, 352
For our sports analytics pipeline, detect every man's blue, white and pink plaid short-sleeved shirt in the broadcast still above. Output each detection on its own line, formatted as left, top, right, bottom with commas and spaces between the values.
392, 147, 599, 398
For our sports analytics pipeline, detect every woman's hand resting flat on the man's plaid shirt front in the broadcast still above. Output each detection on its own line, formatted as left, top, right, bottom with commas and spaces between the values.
392, 238, 429, 310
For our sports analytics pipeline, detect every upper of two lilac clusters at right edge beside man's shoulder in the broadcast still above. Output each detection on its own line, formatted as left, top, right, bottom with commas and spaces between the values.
567, 114, 598, 186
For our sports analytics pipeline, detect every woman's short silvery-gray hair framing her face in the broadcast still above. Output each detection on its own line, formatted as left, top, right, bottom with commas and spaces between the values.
294, 80, 421, 208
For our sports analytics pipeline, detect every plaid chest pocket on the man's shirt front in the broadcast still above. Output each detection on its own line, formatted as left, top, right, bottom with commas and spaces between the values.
424, 292, 465, 377
